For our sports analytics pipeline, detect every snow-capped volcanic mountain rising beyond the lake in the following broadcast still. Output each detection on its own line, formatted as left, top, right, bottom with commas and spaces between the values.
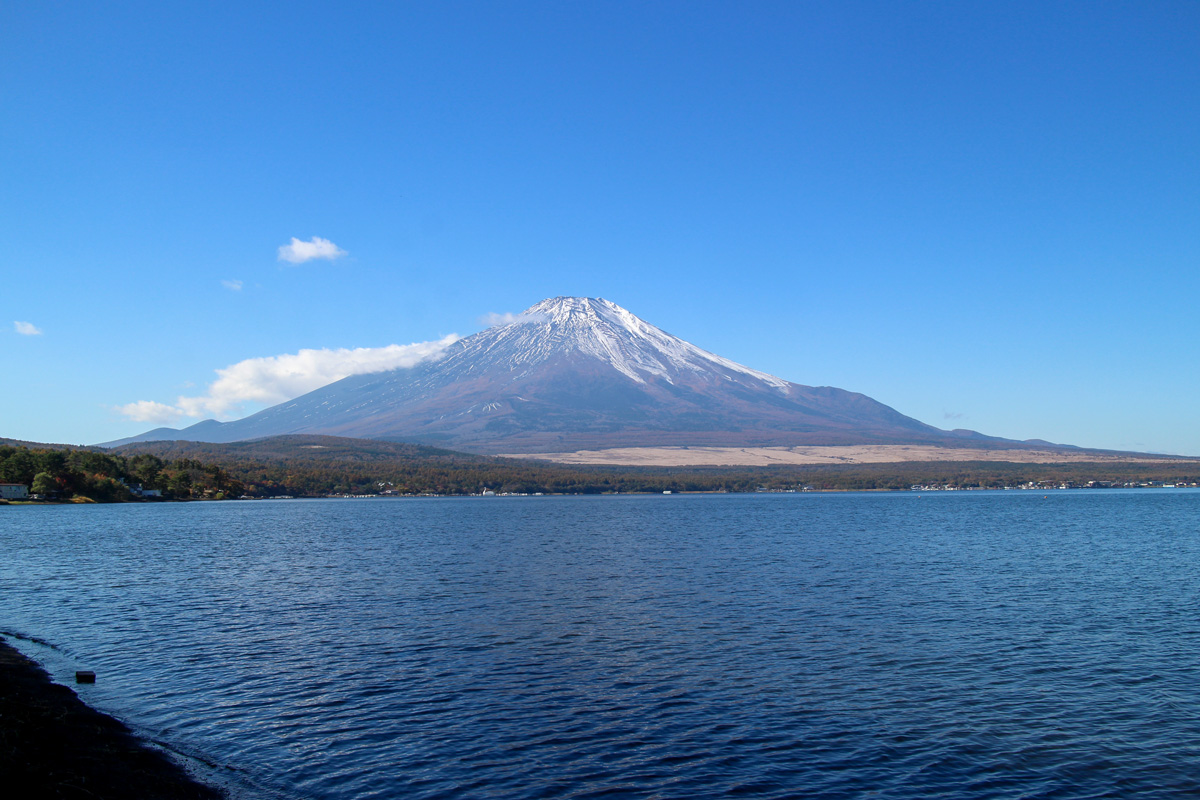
109, 297, 1018, 453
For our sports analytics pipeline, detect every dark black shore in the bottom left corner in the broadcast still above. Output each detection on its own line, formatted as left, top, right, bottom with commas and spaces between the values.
0, 638, 224, 800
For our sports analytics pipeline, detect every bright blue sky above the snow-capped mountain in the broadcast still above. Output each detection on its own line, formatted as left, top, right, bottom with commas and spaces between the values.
0, 1, 1200, 455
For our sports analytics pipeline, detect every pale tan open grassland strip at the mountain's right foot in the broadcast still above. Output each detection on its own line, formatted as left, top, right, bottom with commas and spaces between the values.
505, 445, 1178, 467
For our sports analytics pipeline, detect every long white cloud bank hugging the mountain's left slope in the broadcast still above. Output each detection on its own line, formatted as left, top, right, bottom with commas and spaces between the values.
116, 335, 458, 423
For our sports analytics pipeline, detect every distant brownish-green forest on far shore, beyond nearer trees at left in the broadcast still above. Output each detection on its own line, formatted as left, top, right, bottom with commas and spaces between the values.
121, 435, 1200, 497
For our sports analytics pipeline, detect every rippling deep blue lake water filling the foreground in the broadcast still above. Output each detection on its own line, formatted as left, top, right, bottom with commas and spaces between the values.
0, 489, 1200, 799
